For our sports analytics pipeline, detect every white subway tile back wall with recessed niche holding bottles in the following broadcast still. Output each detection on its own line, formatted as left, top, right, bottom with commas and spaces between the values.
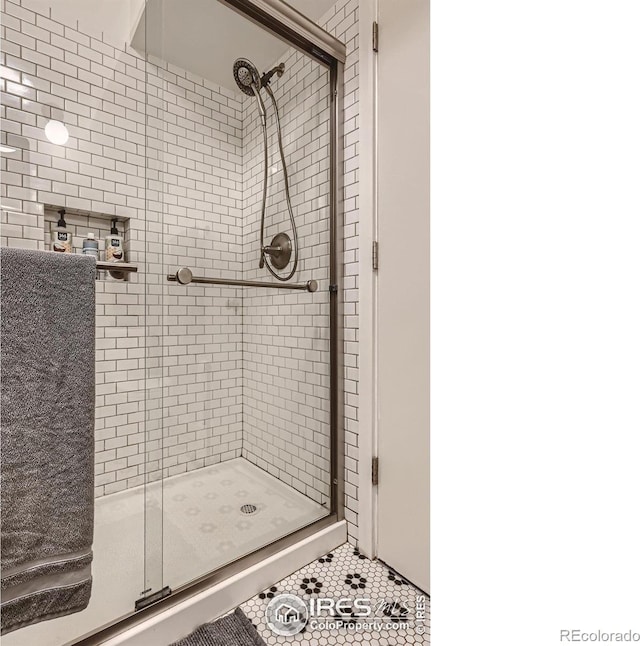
0, 0, 242, 496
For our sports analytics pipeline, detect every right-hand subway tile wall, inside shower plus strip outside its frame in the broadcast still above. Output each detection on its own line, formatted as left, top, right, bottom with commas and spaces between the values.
243, 0, 358, 542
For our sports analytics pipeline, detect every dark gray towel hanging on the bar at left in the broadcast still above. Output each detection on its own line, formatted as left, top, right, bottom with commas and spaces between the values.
0, 248, 96, 634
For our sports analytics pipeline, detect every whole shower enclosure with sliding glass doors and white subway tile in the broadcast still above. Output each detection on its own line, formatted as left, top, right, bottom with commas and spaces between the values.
1, 0, 345, 646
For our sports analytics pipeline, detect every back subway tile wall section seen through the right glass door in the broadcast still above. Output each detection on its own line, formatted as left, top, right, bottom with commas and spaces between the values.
145, 60, 242, 492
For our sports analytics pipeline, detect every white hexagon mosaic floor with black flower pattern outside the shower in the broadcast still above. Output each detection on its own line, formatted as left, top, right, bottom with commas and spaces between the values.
241, 543, 431, 646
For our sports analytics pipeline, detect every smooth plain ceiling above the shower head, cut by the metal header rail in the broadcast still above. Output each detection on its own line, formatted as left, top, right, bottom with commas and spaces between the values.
131, 0, 335, 91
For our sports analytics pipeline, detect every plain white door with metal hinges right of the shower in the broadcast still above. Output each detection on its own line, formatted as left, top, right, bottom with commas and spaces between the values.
377, 0, 429, 592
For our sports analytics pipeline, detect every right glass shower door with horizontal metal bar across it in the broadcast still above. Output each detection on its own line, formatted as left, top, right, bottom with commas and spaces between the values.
139, 0, 332, 593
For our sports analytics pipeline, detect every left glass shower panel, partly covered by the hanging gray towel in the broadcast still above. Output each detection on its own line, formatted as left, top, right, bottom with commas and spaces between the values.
0, 0, 166, 646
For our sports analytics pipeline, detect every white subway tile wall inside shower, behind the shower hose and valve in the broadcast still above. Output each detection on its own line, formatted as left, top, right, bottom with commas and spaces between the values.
242, 40, 331, 504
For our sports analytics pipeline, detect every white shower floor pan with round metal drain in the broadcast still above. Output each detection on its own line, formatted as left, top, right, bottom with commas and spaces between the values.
2, 458, 328, 646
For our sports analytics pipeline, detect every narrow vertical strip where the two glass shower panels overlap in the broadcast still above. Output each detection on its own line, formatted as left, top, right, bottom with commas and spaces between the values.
139, 0, 172, 610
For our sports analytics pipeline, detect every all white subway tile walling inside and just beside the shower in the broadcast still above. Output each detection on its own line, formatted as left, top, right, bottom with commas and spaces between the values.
0, 0, 358, 542
